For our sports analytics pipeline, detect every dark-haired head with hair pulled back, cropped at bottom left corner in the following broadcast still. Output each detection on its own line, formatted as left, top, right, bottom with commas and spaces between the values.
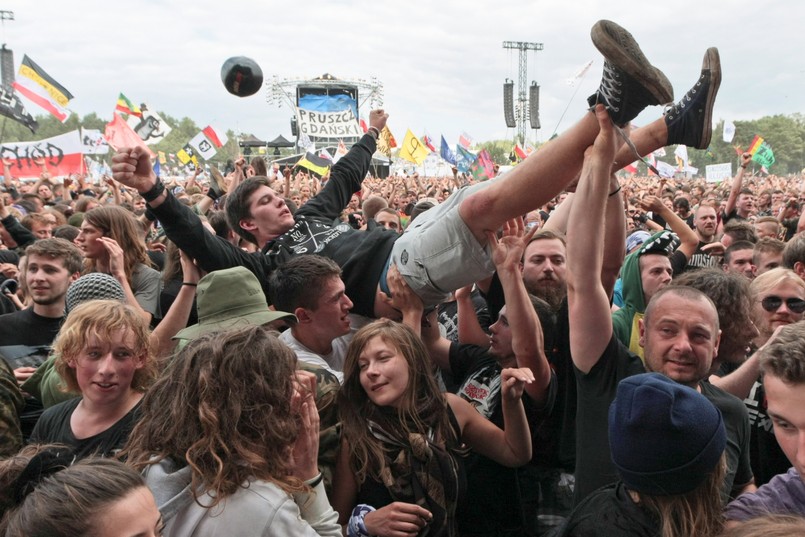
0, 445, 162, 537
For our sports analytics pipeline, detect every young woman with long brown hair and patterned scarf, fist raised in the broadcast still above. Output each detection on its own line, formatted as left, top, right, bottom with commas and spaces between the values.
333, 320, 534, 537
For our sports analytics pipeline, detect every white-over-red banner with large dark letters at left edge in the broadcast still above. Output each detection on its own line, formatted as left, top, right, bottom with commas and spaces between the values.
0, 130, 84, 179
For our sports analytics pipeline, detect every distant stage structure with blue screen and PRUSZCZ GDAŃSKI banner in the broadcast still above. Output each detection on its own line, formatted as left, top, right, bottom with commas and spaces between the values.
266, 73, 383, 147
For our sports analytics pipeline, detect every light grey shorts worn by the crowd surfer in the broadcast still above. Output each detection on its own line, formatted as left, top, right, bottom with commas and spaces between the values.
391, 181, 495, 308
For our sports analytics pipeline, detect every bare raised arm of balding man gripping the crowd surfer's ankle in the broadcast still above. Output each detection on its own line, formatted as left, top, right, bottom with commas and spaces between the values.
567, 105, 617, 373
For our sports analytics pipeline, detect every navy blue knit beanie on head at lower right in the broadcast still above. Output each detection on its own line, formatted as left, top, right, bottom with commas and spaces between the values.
609, 373, 727, 496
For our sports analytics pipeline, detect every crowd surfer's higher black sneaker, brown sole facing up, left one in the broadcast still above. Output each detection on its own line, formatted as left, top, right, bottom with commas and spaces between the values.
587, 20, 674, 126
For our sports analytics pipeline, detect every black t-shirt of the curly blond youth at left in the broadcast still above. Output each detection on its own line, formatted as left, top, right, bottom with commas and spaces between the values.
30, 397, 142, 459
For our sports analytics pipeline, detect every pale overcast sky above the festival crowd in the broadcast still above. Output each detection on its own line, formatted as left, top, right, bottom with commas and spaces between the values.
0, 0, 805, 147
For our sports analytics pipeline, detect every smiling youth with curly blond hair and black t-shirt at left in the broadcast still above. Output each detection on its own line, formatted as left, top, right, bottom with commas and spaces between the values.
31, 300, 156, 458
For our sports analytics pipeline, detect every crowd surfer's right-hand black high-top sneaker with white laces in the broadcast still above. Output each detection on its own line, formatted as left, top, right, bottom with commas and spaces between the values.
665, 47, 721, 149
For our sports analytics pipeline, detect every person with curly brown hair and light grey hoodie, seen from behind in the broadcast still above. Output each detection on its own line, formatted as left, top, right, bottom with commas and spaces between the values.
123, 326, 341, 537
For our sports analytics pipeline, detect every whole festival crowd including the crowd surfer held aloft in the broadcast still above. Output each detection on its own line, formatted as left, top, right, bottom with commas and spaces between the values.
0, 21, 805, 537
